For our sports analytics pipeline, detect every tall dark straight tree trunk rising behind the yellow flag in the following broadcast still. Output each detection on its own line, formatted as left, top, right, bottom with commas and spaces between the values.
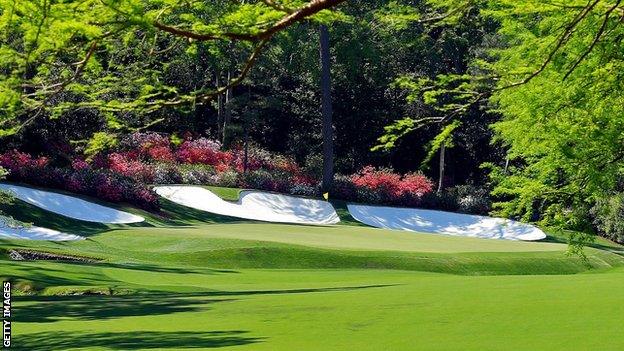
320, 25, 334, 192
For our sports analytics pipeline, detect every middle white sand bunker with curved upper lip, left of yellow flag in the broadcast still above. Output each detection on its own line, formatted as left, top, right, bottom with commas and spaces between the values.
154, 186, 340, 225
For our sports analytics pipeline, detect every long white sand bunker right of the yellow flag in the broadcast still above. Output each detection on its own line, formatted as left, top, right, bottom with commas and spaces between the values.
347, 205, 546, 240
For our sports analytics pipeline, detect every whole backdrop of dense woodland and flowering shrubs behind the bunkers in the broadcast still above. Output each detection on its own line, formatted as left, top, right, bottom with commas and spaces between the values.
0, 0, 624, 245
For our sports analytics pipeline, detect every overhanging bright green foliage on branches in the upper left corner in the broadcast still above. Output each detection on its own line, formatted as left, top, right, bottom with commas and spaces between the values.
0, 0, 344, 136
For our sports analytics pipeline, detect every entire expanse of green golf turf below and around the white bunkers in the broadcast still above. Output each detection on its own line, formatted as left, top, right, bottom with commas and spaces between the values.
0, 189, 624, 350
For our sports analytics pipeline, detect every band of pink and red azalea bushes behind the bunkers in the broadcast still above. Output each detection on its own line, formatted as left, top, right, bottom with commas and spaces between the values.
0, 132, 433, 209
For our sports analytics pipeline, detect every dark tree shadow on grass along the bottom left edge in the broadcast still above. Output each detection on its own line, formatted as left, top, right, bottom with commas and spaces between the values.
13, 332, 266, 350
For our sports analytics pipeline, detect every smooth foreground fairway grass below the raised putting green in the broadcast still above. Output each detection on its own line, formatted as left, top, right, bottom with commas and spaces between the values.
14, 270, 624, 350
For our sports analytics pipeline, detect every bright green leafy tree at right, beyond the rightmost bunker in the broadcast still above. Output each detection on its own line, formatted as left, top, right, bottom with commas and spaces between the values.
490, 1, 624, 229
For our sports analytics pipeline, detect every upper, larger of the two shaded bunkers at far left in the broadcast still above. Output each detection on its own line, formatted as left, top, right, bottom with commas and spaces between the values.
0, 184, 145, 223
